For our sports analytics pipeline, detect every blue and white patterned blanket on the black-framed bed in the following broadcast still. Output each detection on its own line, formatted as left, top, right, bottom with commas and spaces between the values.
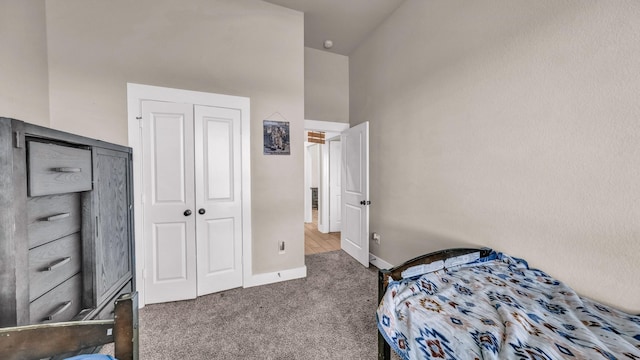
377, 252, 640, 360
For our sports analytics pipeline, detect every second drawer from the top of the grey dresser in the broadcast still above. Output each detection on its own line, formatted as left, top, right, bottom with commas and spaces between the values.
27, 193, 82, 248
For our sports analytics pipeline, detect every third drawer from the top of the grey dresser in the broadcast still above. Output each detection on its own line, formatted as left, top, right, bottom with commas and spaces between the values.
29, 233, 82, 301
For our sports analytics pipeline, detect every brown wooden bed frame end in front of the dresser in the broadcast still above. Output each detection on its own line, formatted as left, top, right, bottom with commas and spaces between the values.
0, 292, 138, 360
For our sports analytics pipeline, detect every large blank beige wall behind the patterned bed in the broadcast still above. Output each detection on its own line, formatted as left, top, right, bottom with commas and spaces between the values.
349, 0, 640, 313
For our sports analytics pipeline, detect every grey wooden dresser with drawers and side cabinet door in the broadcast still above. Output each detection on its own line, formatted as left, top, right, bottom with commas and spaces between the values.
0, 118, 135, 327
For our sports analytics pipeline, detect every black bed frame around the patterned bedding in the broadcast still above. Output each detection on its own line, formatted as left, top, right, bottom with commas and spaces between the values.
378, 247, 491, 360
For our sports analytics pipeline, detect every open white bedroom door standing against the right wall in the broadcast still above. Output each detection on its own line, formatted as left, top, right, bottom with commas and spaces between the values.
340, 122, 370, 267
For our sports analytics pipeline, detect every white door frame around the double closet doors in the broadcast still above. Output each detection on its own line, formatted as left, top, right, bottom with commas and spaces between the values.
127, 83, 253, 308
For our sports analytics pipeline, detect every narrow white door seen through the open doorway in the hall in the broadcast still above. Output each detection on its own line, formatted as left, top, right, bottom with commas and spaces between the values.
328, 137, 342, 232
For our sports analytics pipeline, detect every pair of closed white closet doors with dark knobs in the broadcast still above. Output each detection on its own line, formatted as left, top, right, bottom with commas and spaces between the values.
139, 100, 243, 304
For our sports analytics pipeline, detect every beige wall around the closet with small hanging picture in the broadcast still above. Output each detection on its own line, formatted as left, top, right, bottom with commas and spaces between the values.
47, 0, 304, 273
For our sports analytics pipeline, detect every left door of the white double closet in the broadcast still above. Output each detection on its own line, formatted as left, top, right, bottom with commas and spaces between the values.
141, 101, 196, 303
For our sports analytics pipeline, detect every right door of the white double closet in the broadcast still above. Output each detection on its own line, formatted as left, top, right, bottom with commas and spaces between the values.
194, 105, 242, 295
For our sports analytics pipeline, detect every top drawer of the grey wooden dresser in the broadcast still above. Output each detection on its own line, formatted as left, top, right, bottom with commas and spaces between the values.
28, 141, 91, 196
